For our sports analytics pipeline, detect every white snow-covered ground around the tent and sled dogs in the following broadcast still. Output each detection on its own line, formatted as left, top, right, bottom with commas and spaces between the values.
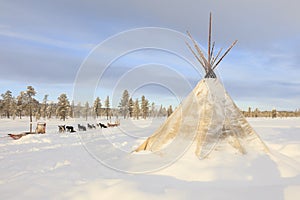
0, 118, 300, 200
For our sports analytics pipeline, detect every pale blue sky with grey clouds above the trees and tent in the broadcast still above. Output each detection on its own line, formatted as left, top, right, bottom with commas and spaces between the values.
0, 0, 300, 110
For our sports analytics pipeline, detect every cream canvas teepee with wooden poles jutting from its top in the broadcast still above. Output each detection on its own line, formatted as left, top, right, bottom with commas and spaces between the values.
135, 14, 268, 158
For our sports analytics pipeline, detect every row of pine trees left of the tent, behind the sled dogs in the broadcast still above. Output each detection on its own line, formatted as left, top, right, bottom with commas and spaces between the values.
0, 86, 173, 122
